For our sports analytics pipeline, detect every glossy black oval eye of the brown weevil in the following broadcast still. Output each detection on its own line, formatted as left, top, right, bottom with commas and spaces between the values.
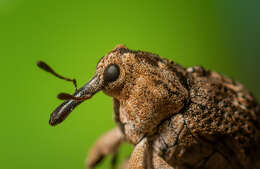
104, 64, 120, 83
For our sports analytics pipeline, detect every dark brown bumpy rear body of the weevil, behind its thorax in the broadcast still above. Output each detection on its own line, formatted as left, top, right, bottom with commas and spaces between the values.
154, 67, 260, 169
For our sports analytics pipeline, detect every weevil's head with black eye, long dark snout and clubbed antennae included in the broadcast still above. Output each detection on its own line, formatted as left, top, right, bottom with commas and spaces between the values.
37, 46, 126, 126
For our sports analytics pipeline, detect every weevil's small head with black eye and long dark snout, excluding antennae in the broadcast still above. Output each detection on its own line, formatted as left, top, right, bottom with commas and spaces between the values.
49, 45, 133, 126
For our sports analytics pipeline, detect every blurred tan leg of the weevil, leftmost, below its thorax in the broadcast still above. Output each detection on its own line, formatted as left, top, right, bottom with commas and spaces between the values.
86, 127, 124, 169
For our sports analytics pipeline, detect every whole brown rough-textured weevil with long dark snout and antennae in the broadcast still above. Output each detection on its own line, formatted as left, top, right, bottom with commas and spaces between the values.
38, 45, 260, 169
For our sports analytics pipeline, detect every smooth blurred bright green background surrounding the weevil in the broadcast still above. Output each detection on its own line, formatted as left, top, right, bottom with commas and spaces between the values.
0, 0, 260, 169
